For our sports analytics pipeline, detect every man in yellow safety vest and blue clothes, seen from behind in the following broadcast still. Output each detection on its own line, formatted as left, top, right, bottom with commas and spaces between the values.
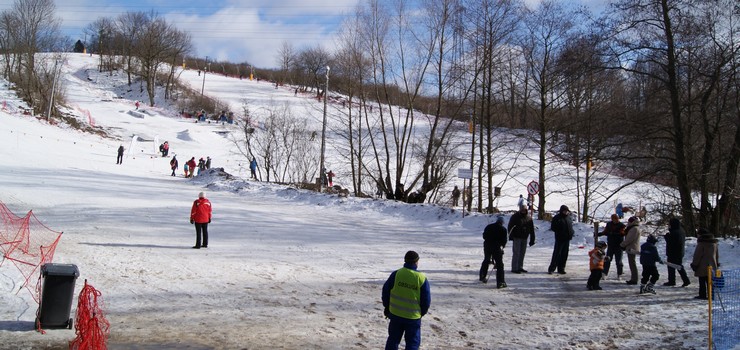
382, 250, 432, 350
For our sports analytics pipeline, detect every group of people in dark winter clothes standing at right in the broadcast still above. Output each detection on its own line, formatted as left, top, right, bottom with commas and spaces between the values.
479, 205, 719, 299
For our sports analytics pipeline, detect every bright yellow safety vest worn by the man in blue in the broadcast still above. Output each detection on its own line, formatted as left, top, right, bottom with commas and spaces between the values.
388, 267, 427, 320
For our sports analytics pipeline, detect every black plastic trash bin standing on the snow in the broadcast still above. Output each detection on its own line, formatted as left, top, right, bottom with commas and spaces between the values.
36, 263, 80, 329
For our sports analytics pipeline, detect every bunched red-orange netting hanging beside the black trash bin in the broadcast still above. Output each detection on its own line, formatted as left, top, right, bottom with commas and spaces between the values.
69, 280, 110, 350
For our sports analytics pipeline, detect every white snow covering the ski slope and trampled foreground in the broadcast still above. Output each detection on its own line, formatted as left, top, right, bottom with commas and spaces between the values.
0, 54, 740, 349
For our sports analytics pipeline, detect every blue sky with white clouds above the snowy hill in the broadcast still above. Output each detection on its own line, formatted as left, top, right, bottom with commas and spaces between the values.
0, 0, 606, 68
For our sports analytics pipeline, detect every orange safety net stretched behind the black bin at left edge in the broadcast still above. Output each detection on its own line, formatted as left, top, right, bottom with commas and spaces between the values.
0, 202, 62, 303
